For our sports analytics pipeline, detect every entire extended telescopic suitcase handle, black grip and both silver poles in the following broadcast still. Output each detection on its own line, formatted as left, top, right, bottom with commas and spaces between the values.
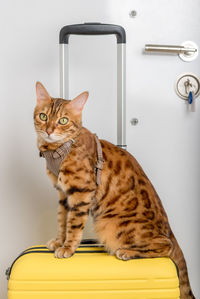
59, 23, 126, 149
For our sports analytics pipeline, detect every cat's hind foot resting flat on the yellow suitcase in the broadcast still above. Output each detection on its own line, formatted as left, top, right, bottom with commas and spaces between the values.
115, 236, 173, 261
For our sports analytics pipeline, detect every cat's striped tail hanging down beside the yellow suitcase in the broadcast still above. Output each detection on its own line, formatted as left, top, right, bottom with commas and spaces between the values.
170, 235, 195, 299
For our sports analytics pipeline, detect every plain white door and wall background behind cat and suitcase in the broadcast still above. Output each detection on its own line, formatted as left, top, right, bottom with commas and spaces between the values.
0, 0, 200, 299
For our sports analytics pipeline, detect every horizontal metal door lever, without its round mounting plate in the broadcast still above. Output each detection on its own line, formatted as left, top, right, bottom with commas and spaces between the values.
145, 44, 197, 55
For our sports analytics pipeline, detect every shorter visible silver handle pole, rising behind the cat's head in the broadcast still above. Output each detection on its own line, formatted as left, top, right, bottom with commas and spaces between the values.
60, 44, 69, 99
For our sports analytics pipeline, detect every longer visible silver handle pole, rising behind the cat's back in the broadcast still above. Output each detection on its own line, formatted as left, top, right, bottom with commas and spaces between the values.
117, 44, 126, 149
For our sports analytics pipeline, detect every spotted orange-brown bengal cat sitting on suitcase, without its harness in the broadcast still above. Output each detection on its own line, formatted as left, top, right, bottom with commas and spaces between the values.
34, 82, 195, 299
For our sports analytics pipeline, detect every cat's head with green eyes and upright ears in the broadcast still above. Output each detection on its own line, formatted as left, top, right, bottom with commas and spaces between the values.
34, 82, 88, 143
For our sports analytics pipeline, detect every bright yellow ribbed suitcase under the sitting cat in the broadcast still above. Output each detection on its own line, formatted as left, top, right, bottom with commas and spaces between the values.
7, 244, 180, 299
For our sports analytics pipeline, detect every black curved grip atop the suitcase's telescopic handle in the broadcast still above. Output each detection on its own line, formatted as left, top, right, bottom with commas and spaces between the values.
59, 23, 126, 44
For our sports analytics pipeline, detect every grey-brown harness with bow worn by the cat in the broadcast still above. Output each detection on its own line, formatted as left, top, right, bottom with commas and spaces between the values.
40, 134, 104, 185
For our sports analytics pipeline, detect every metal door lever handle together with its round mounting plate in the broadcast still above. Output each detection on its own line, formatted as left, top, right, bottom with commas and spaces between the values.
145, 41, 198, 61
